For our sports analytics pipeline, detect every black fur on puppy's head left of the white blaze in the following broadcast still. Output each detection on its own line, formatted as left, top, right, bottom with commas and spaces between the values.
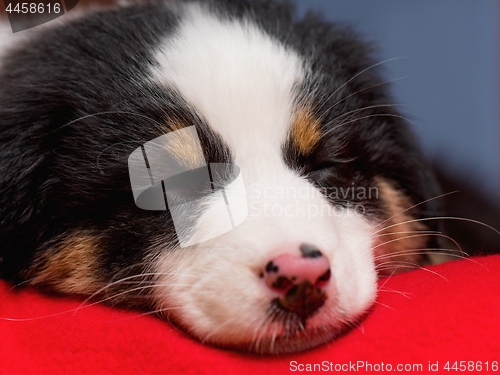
0, 2, 234, 281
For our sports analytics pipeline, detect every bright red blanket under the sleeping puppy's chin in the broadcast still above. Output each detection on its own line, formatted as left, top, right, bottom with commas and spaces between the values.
0, 256, 500, 375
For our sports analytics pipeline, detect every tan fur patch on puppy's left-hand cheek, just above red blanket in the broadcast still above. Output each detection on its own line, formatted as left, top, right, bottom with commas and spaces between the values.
32, 232, 104, 295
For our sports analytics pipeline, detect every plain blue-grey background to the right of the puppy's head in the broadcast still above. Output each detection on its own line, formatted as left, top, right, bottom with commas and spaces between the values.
294, 0, 500, 203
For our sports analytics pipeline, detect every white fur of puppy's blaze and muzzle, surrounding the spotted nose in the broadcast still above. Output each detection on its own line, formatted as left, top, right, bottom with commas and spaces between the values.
152, 4, 376, 352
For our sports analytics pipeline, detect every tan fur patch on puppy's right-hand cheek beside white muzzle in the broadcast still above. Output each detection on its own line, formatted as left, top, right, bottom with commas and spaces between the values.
374, 179, 428, 276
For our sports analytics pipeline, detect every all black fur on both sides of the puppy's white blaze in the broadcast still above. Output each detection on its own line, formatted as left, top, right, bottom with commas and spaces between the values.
0, 0, 437, 300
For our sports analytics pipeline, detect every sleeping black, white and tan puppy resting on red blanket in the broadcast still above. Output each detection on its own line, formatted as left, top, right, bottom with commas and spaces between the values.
0, 0, 438, 353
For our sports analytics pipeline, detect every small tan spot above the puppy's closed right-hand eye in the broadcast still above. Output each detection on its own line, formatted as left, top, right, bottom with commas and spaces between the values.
291, 106, 321, 155
